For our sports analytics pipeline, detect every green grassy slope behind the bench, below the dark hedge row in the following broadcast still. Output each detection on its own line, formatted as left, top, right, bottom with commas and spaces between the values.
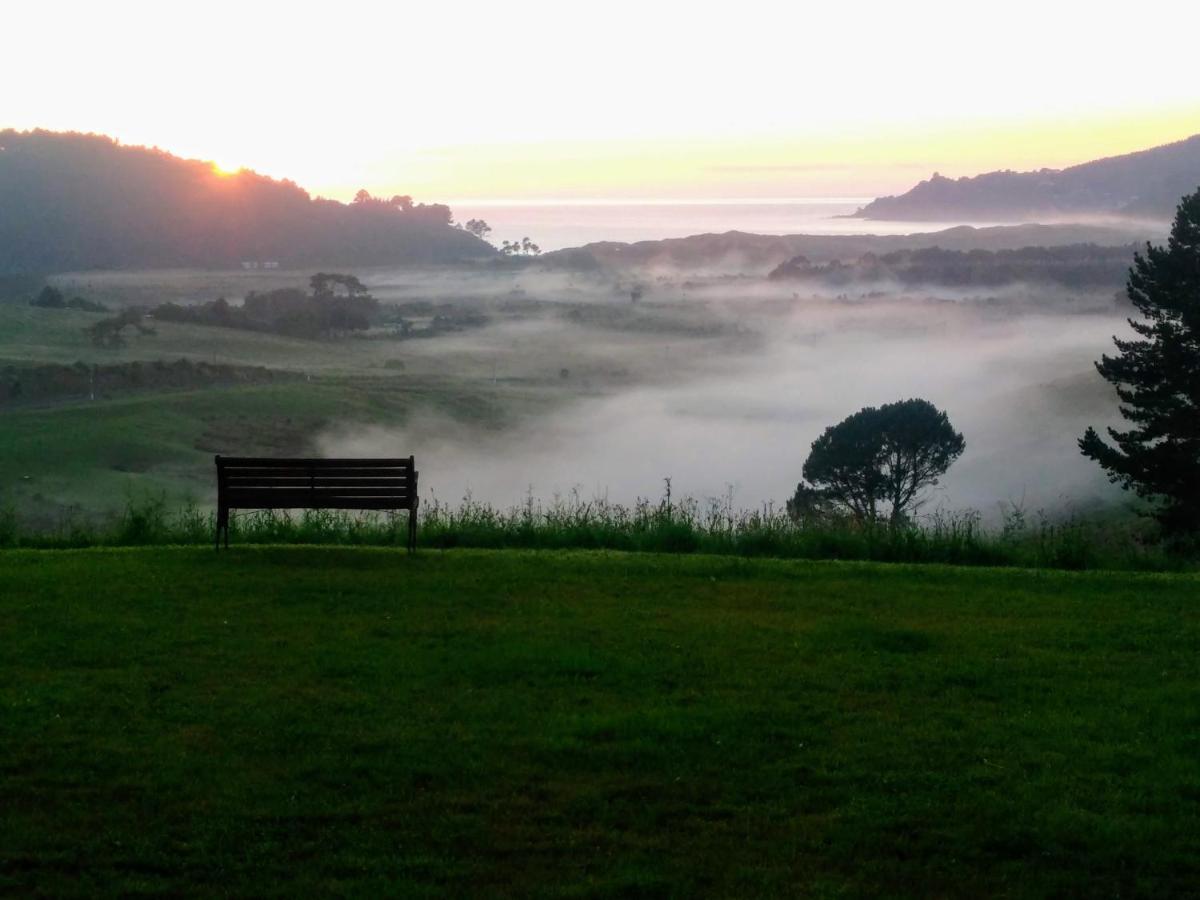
0, 376, 515, 522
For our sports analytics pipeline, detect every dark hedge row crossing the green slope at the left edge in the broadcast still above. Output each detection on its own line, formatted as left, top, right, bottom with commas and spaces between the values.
0, 359, 290, 406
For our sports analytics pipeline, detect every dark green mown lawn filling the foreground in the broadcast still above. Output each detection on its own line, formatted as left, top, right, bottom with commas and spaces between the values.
0, 547, 1200, 898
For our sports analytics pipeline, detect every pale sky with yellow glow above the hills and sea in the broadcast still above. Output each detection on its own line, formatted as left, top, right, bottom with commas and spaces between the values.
0, 0, 1200, 202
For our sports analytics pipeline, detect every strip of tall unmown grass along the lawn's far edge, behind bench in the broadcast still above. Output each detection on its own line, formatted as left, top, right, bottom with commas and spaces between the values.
0, 485, 1180, 570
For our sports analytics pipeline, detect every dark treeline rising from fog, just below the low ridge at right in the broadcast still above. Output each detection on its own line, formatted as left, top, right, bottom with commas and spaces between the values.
768, 244, 1134, 289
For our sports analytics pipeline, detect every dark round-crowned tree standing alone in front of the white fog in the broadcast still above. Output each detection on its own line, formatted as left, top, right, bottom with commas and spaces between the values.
788, 400, 966, 524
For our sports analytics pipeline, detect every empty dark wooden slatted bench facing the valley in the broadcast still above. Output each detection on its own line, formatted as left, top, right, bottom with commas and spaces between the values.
216, 456, 418, 552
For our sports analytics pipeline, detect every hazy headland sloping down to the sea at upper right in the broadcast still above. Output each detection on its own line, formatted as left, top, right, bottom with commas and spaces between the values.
854, 134, 1200, 222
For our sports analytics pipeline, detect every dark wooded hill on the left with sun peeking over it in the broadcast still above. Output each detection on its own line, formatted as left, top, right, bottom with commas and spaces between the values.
0, 130, 494, 272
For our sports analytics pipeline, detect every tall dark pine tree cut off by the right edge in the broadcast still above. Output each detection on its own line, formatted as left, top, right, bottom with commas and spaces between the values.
1079, 190, 1200, 534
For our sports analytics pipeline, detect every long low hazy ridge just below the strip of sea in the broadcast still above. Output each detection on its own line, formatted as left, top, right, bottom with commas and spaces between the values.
538, 224, 1162, 275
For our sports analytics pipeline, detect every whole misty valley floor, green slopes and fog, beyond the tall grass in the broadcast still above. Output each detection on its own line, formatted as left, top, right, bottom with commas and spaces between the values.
0, 224, 1161, 526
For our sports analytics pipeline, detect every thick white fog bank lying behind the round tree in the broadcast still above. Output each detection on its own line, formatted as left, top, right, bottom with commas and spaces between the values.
318, 264, 1126, 518
